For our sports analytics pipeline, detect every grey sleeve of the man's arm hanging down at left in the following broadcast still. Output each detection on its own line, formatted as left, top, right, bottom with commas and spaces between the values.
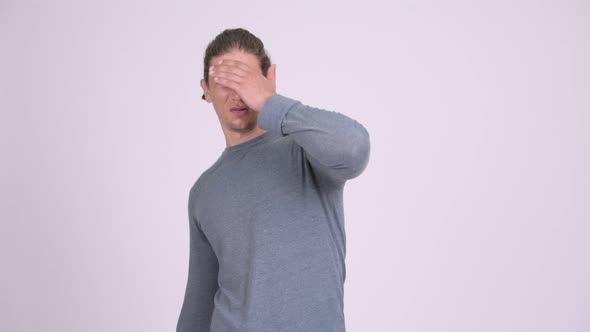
176, 190, 219, 332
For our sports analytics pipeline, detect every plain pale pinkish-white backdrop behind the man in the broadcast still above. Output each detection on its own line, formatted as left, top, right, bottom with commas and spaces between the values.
0, 0, 590, 332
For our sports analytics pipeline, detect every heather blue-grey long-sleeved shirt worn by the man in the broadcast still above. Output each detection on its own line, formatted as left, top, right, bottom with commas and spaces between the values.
176, 94, 370, 332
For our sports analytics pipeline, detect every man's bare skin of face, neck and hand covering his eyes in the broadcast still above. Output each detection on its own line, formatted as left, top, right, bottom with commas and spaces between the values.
201, 49, 277, 147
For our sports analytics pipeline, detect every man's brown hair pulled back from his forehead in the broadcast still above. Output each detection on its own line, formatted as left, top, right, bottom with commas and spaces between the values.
201, 28, 271, 100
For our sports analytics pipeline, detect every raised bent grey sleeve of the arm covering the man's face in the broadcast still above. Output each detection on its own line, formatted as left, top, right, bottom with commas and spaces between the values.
258, 94, 370, 183
